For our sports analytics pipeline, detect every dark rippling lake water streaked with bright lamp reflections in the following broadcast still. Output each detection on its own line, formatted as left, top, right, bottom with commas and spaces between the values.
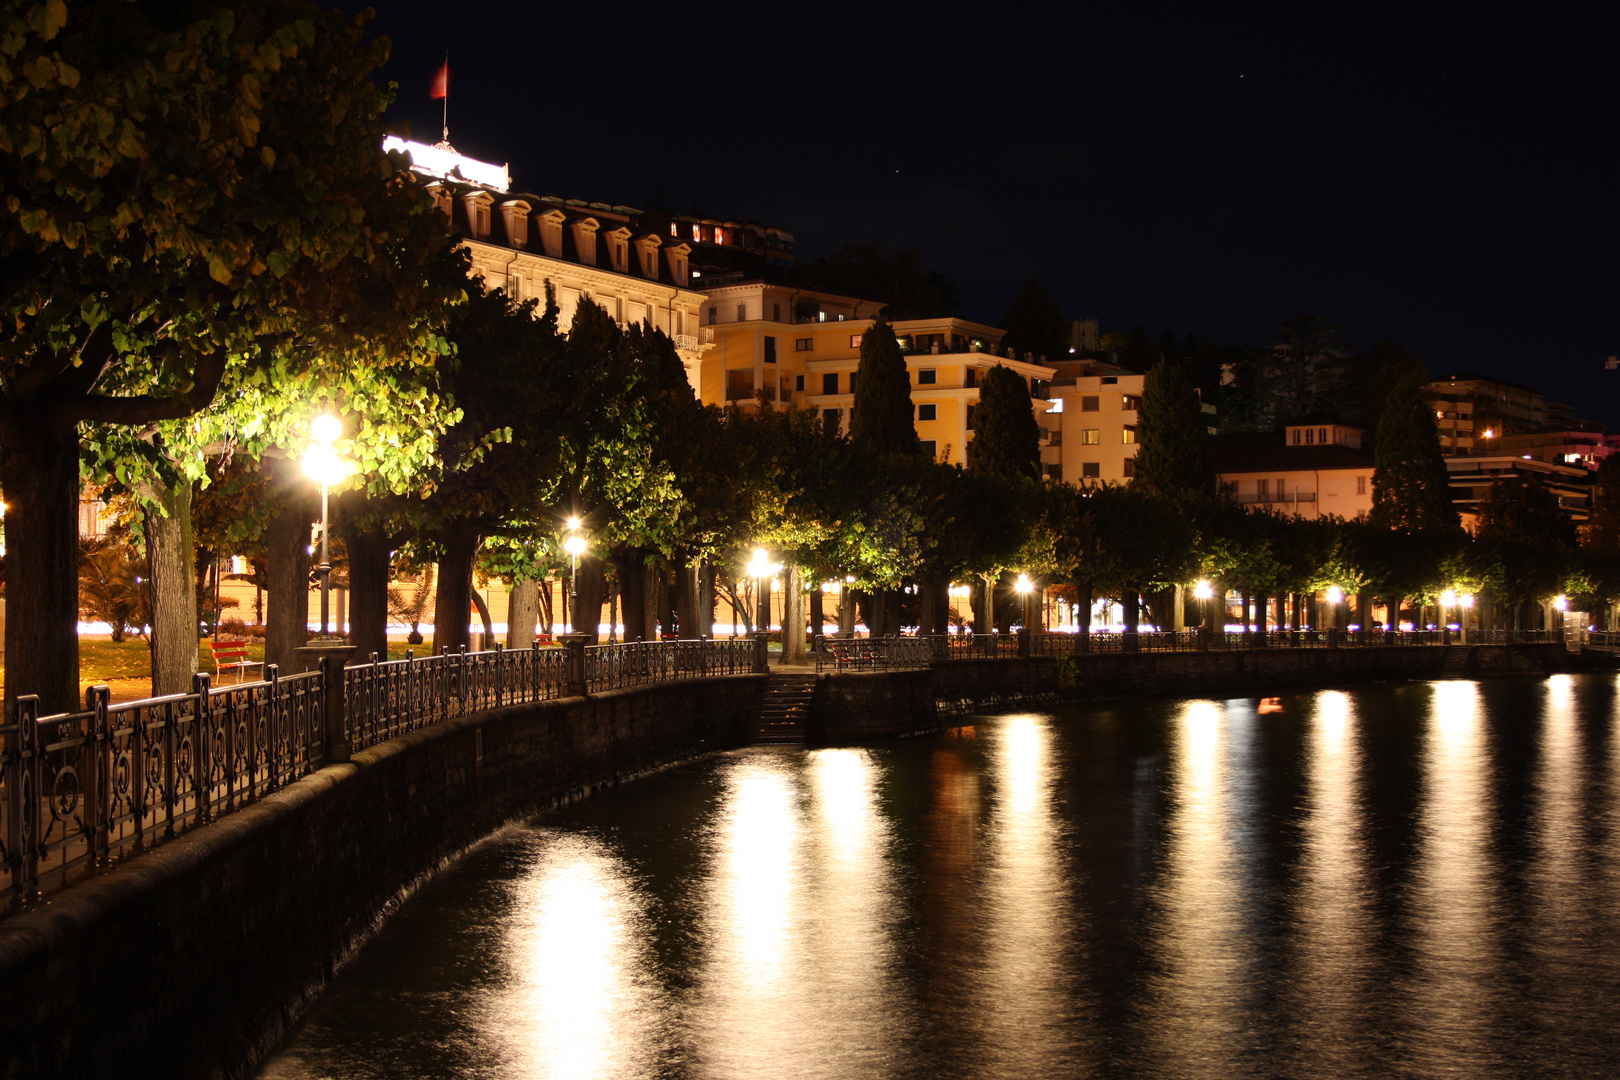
264, 675, 1620, 1080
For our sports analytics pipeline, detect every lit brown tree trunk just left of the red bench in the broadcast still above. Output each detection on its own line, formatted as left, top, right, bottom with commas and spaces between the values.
143, 479, 198, 696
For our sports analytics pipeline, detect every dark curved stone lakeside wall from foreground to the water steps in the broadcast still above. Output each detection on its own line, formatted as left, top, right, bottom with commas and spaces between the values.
0, 675, 766, 1080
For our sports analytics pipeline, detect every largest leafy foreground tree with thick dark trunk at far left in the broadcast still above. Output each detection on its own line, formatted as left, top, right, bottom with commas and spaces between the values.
0, 0, 456, 711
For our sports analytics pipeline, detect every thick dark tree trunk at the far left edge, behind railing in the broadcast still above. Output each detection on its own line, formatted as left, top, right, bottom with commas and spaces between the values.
0, 410, 79, 719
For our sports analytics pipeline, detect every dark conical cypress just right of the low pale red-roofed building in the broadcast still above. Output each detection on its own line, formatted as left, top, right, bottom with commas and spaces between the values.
1372, 371, 1460, 533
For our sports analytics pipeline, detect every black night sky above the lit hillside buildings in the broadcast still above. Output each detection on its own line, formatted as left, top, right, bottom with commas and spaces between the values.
361, 0, 1620, 424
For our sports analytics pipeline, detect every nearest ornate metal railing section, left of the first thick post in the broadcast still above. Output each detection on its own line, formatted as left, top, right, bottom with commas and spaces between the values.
0, 665, 324, 907
